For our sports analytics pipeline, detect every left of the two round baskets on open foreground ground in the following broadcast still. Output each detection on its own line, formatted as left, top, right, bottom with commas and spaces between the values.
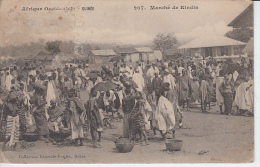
115, 138, 134, 153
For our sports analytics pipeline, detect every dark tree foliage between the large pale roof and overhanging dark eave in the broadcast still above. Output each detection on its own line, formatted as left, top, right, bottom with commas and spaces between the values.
225, 28, 254, 43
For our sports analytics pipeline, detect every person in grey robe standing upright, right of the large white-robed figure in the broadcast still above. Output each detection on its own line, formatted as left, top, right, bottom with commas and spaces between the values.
178, 70, 191, 110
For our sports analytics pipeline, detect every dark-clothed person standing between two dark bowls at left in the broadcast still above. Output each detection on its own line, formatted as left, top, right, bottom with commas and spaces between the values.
30, 85, 50, 142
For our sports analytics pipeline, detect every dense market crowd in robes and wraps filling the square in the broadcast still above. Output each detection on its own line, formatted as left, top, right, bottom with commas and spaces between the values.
0, 58, 254, 150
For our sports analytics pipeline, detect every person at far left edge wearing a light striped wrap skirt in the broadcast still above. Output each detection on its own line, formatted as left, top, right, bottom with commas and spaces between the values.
2, 91, 20, 151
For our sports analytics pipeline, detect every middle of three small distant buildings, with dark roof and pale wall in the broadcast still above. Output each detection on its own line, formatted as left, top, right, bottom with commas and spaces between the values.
114, 47, 139, 62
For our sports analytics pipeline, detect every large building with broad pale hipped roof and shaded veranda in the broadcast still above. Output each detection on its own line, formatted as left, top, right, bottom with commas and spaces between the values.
178, 36, 246, 57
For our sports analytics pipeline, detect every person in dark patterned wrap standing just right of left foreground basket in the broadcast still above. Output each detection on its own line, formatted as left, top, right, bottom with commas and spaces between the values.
129, 92, 149, 145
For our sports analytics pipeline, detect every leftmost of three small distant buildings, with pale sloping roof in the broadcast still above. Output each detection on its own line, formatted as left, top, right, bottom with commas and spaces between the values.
88, 49, 117, 64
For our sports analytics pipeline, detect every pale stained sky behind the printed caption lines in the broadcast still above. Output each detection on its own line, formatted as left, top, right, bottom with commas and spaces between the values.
0, 0, 251, 46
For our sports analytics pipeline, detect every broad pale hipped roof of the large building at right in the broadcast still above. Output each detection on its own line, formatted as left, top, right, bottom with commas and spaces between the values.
178, 36, 246, 49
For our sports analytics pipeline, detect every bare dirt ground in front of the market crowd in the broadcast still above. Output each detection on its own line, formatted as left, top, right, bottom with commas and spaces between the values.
0, 88, 254, 163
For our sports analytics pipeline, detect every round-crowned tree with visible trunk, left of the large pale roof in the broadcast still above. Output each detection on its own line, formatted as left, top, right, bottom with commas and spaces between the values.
153, 33, 178, 59
